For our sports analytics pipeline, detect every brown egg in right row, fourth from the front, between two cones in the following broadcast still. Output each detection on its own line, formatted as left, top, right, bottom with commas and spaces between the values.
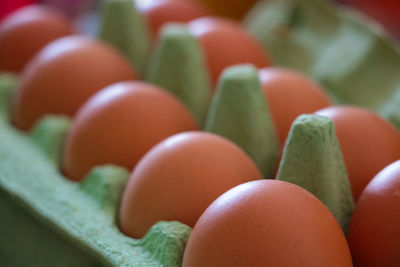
188, 17, 271, 88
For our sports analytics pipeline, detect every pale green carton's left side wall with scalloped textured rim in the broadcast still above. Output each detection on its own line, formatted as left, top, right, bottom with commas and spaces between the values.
0, 76, 191, 266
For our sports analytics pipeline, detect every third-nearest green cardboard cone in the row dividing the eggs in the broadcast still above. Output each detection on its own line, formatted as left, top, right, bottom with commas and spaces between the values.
147, 24, 212, 128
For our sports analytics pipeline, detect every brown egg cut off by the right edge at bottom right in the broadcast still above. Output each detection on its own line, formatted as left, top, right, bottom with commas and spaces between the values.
347, 160, 400, 267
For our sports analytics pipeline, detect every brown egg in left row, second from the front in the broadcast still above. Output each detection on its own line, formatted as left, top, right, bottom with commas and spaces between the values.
119, 131, 262, 238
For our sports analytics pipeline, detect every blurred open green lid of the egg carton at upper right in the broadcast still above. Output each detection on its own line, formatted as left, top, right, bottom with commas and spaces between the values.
244, 0, 400, 129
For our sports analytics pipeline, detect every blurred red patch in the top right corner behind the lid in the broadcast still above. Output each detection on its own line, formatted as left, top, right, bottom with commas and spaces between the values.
339, 0, 400, 39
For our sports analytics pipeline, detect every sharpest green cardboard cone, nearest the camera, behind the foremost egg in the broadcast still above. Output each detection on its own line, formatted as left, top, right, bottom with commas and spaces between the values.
276, 115, 354, 233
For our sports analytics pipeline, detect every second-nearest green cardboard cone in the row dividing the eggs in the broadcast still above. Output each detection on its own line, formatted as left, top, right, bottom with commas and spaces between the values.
205, 65, 279, 179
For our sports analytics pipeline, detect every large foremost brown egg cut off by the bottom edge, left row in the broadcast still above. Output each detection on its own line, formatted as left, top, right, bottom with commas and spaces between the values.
182, 180, 352, 267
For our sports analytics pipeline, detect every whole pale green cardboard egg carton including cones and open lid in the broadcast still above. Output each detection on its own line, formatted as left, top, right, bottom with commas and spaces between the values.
0, 0, 400, 266
